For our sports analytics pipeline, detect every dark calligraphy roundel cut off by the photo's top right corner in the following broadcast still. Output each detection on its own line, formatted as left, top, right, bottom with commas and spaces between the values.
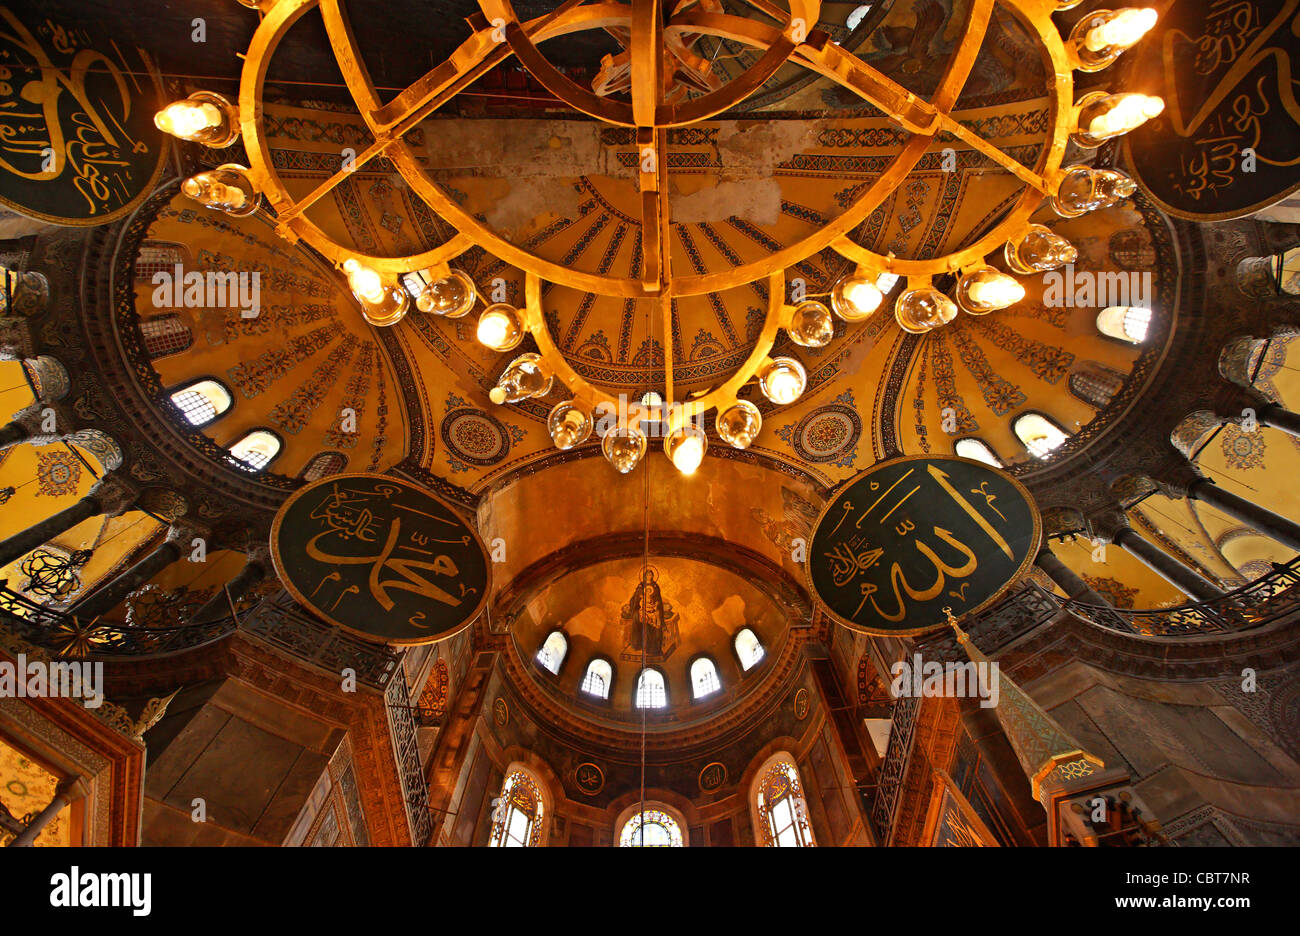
1125, 0, 1300, 221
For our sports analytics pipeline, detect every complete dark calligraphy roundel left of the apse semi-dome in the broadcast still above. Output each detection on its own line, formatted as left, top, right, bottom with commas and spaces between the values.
270, 475, 490, 645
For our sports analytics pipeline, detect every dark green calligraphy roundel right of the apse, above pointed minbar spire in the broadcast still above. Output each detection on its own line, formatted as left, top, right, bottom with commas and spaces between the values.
807, 455, 1041, 636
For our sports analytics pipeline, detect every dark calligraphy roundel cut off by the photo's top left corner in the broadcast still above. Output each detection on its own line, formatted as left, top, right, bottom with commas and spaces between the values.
0, 4, 168, 225
